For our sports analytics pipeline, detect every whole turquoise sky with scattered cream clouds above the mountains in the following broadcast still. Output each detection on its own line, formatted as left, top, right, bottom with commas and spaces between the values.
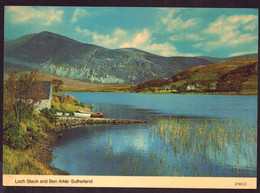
4, 6, 258, 58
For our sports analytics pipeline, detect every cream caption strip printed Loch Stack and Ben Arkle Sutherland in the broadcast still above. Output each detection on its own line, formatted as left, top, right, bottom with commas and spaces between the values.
3, 175, 257, 189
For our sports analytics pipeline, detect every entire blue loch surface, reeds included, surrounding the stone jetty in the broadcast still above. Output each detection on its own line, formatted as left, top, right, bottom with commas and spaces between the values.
52, 92, 257, 177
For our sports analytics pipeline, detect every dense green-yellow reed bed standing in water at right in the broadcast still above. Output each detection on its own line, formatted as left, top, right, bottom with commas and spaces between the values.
147, 117, 257, 176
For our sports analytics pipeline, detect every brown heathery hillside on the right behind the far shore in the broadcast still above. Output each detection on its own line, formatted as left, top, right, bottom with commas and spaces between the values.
134, 58, 258, 94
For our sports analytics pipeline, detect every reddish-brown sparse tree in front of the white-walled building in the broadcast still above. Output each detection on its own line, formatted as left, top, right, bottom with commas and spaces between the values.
5, 70, 44, 122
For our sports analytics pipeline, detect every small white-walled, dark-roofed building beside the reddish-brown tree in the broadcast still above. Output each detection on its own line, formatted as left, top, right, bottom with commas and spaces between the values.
35, 81, 52, 111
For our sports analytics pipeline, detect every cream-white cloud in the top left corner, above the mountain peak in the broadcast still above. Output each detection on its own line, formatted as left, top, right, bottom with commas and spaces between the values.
6, 6, 63, 26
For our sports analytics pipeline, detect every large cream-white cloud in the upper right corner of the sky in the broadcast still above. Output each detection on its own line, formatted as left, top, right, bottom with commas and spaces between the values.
204, 15, 258, 50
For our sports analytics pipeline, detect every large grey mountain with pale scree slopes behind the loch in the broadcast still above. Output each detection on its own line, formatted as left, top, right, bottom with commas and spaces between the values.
4, 31, 258, 84
